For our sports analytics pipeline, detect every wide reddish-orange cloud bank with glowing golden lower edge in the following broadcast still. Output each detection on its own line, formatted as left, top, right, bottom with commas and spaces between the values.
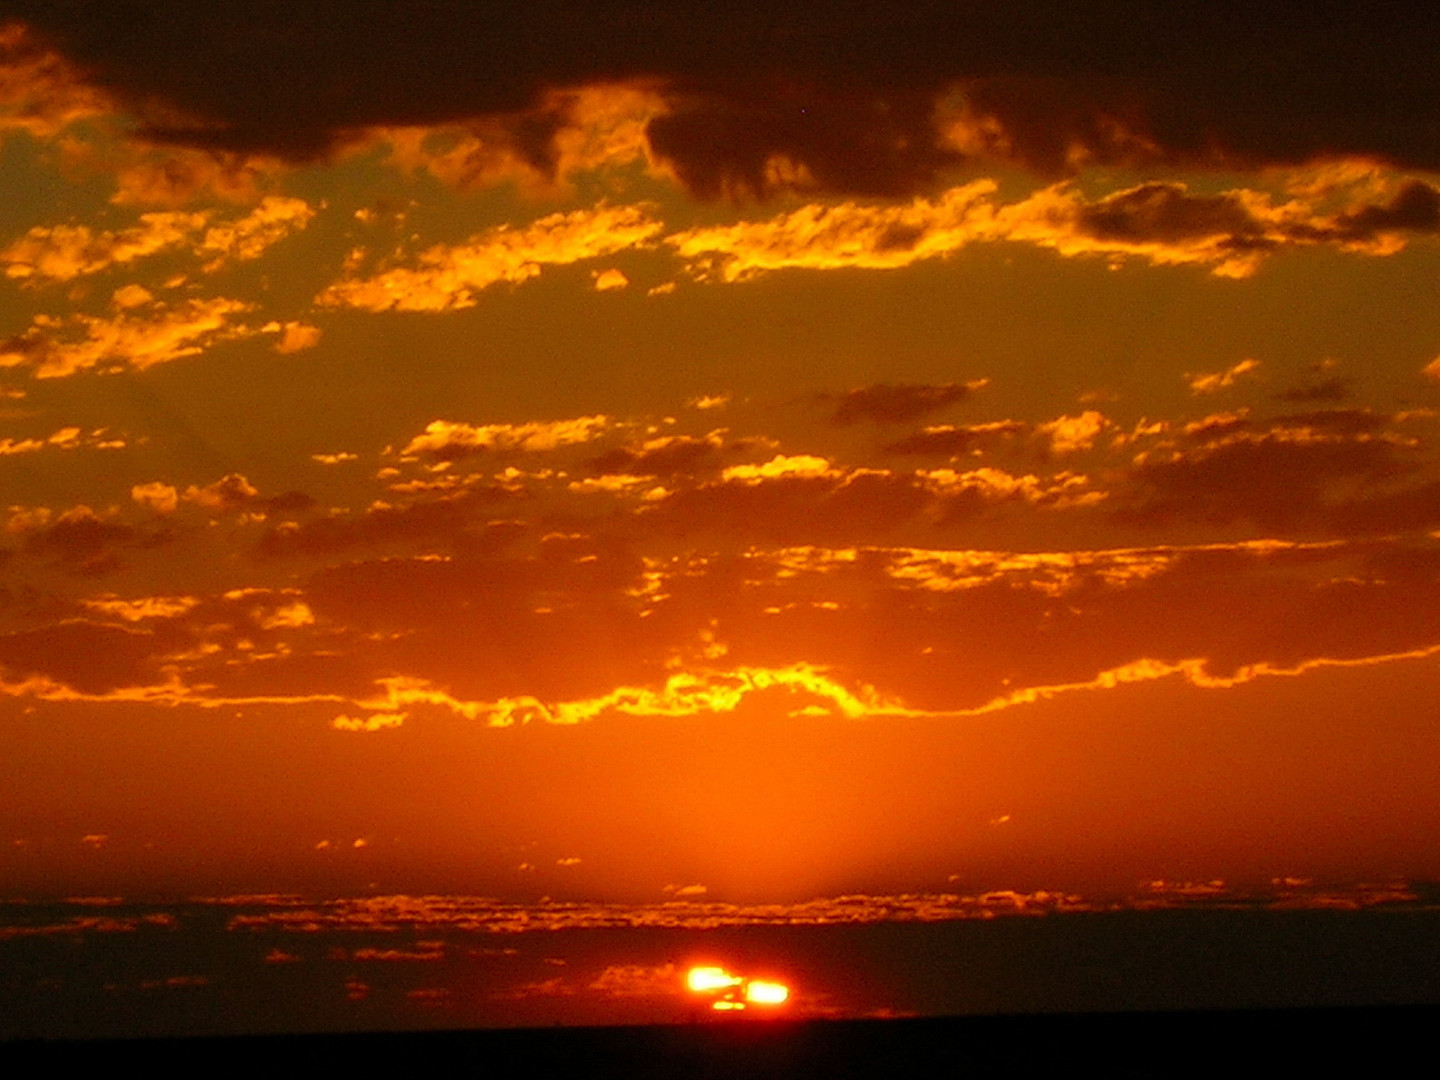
8, 506, 1440, 733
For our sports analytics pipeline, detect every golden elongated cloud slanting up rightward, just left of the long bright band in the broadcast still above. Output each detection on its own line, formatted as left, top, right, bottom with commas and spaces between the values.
315, 204, 662, 311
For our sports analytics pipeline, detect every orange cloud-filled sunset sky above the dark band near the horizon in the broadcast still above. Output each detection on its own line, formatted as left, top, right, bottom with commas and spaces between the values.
0, 0, 1440, 921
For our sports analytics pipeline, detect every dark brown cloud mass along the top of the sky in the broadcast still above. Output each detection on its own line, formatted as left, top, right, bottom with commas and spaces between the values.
7, 0, 1440, 194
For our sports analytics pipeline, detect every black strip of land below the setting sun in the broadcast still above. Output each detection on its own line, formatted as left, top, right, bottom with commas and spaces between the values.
0, 1005, 1440, 1080
